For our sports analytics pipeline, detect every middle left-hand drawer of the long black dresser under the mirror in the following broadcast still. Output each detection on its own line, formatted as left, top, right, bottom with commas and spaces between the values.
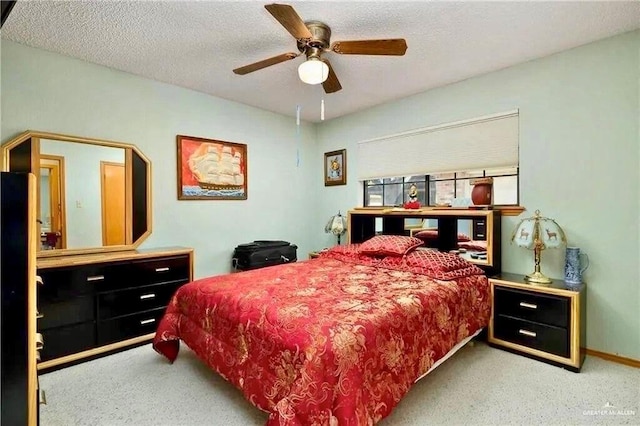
38, 295, 96, 330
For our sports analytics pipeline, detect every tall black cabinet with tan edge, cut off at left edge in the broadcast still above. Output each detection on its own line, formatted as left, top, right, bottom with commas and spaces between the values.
0, 172, 39, 426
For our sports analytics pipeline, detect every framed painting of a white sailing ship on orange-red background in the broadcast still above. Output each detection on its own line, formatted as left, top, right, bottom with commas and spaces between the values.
177, 135, 247, 200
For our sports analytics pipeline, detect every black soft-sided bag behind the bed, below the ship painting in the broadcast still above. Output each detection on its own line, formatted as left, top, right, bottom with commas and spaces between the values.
231, 240, 298, 271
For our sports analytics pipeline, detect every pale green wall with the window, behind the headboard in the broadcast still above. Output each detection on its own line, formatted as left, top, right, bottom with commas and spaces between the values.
316, 31, 640, 359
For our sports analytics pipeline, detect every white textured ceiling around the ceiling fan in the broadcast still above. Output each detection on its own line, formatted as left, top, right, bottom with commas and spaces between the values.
2, 0, 640, 122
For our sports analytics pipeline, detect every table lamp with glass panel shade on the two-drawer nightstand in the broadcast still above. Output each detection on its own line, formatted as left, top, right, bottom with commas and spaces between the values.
511, 210, 567, 285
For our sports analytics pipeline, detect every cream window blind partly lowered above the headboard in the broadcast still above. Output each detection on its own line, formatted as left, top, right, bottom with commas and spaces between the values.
358, 111, 518, 180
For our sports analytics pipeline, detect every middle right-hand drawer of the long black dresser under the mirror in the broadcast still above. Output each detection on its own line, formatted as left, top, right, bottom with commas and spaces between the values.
98, 281, 184, 320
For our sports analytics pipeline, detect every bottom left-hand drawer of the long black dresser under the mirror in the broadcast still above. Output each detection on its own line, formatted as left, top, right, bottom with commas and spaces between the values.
40, 321, 96, 361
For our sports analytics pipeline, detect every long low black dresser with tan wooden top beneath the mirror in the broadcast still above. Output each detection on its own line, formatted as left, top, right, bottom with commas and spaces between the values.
37, 247, 193, 370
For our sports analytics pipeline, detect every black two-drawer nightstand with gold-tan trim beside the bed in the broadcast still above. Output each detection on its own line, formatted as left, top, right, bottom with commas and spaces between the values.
488, 273, 586, 373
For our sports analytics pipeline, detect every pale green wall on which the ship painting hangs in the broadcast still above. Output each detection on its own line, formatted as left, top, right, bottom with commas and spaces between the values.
0, 40, 317, 277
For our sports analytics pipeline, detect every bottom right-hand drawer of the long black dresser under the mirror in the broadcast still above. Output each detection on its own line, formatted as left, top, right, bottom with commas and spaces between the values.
98, 308, 165, 345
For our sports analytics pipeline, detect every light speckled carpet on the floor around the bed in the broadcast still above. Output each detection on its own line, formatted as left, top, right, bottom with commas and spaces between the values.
40, 343, 640, 426
